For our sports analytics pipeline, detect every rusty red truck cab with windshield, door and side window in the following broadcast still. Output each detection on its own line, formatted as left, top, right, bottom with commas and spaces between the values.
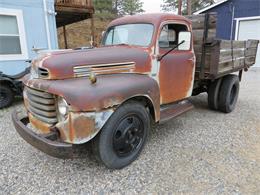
103, 14, 195, 104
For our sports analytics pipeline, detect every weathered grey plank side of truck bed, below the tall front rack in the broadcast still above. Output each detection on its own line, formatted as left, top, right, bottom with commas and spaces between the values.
197, 40, 259, 79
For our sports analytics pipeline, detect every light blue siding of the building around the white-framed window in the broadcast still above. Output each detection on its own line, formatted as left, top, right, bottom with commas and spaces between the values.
0, 0, 58, 75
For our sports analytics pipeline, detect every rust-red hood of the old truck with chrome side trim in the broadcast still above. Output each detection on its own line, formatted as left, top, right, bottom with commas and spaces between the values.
39, 46, 151, 80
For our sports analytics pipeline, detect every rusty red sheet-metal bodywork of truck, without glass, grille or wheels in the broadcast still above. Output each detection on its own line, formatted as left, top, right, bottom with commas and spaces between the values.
21, 14, 194, 144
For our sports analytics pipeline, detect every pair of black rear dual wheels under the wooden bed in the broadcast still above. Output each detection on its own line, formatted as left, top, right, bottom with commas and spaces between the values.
208, 75, 239, 113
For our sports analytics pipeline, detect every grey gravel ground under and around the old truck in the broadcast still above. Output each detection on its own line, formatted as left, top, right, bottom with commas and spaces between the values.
0, 71, 260, 194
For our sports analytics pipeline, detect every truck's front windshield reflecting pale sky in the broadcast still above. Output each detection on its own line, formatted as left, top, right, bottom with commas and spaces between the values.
103, 24, 153, 47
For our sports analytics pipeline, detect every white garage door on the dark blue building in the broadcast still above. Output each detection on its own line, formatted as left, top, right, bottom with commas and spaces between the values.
237, 19, 260, 67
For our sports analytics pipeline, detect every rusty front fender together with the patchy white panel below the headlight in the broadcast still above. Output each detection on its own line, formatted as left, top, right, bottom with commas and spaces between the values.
24, 73, 160, 144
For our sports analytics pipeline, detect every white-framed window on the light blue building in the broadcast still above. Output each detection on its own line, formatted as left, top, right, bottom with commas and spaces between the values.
0, 9, 27, 60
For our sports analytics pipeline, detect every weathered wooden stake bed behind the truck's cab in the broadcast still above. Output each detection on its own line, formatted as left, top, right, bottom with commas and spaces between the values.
187, 13, 259, 80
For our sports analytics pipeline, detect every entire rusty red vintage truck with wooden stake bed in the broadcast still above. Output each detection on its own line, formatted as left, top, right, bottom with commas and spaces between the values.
12, 14, 258, 169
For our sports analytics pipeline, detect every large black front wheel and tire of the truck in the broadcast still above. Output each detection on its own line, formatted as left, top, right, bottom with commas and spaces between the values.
92, 101, 150, 169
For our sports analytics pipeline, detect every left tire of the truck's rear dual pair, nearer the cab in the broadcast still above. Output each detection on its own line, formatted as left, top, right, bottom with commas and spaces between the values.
208, 79, 222, 110
